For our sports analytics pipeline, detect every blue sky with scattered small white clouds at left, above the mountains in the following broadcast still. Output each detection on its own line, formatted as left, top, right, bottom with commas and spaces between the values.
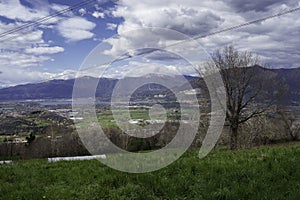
0, 0, 123, 86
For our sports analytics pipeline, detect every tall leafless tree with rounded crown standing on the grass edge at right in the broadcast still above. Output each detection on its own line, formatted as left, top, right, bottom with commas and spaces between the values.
205, 46, 284, 149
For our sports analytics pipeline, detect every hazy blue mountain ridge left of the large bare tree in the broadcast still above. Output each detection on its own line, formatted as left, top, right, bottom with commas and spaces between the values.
0, 74, 197, 101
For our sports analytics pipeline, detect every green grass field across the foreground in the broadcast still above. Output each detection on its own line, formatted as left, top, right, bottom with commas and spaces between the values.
0, 146, 300, 200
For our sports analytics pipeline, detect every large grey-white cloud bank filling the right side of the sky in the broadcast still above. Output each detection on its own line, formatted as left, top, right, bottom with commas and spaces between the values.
105, 0, 300, 67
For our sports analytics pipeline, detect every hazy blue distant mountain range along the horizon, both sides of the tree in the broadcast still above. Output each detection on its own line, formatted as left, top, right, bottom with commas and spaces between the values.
0, 66, 300, 103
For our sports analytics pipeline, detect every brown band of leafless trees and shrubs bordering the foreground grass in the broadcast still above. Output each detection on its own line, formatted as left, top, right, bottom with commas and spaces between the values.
0, 114, 300, 159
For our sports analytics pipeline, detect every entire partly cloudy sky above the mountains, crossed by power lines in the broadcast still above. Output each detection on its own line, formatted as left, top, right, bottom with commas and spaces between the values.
0, 0, 300, 87
